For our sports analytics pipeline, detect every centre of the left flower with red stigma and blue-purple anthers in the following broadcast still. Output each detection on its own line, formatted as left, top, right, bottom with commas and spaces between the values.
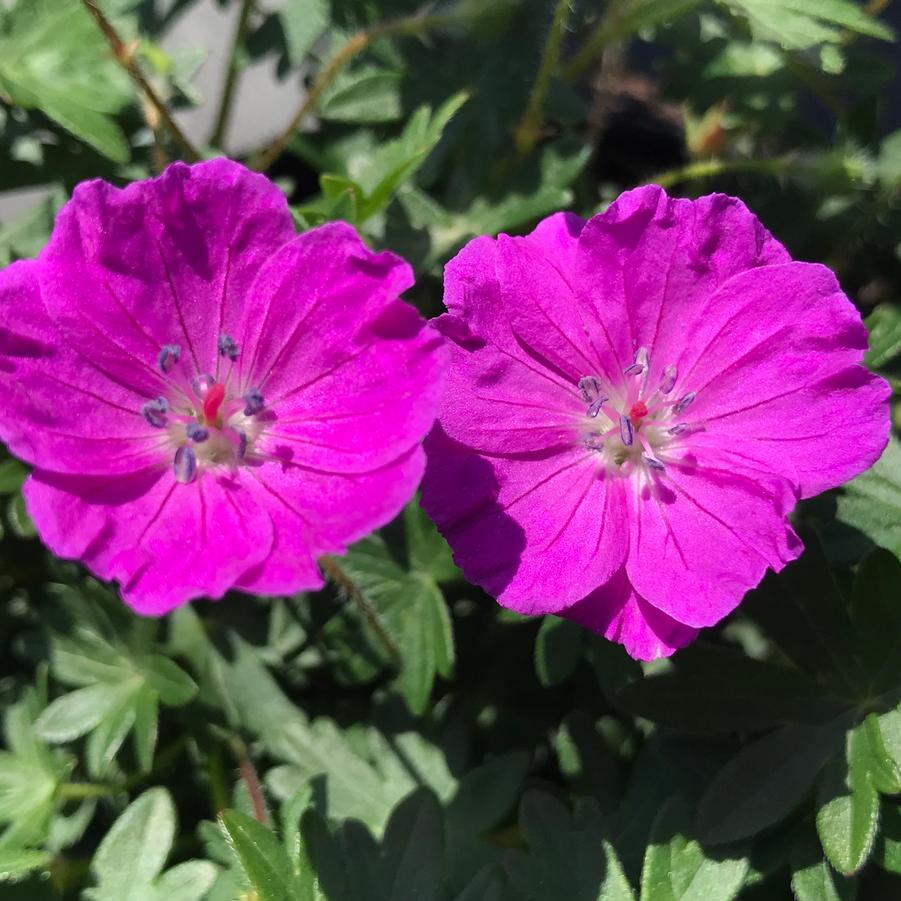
141, 335, 265, 484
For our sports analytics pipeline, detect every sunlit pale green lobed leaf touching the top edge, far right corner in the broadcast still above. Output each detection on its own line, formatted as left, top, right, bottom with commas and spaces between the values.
720, 0, 894, 50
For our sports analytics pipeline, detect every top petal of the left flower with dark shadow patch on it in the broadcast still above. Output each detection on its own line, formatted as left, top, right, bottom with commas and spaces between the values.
40, 160, 294, 396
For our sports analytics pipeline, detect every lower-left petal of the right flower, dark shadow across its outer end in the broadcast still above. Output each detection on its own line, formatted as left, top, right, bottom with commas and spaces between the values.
422, 428, 628, 614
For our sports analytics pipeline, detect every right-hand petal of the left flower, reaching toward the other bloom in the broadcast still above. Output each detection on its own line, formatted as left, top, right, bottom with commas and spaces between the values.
237, 223, 445, 472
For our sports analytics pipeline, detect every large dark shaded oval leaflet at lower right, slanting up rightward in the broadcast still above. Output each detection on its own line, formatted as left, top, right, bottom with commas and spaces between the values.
697, 718, 846, 844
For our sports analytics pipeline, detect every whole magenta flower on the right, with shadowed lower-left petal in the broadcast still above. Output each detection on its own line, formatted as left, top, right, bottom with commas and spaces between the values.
423, 187, 889, 659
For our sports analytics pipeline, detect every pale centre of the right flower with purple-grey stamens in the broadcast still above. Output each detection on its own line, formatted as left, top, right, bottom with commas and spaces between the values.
579, 347, 704, 476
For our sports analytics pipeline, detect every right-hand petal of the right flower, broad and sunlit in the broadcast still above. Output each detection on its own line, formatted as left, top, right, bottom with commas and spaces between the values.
680, 263, 890, 497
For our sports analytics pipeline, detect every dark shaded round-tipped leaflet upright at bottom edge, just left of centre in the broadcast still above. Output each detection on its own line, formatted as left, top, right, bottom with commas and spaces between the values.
382, 790, 444, 901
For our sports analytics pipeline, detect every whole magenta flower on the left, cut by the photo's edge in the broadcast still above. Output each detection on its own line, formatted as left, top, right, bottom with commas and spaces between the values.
0, 160, 446, 614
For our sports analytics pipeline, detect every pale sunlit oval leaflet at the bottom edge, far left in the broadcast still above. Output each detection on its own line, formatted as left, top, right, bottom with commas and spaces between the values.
86, 788, 175, 901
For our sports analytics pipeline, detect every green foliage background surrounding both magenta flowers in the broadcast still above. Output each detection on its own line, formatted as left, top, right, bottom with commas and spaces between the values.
0, 0, 901, 901
